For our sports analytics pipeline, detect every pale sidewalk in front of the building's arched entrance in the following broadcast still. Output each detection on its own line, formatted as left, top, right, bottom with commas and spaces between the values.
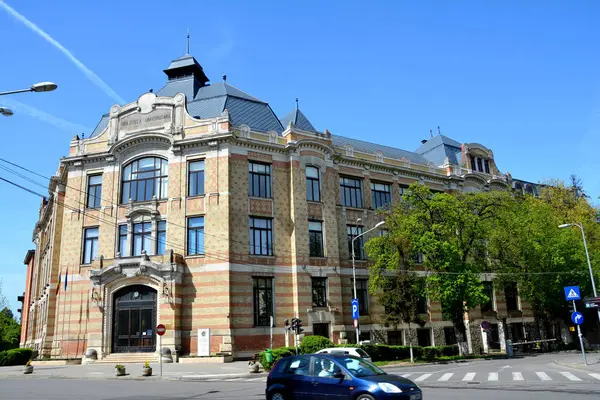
0, 361, 266, 381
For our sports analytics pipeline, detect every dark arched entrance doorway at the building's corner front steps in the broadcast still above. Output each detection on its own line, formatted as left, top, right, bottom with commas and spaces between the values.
112, 285, 156, 353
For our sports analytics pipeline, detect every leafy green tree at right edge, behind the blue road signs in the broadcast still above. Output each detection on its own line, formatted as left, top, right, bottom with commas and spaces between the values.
489, 182, 600, 336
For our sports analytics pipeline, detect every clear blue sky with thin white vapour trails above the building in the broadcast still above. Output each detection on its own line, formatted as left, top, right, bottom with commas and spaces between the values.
0, 0, 600, 316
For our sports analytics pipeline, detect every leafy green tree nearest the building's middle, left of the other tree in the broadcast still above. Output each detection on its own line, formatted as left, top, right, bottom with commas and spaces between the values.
373, 184, 510, 352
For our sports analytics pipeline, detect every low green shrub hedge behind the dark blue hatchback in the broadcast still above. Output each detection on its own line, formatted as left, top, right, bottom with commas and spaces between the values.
260, 336, 458, 371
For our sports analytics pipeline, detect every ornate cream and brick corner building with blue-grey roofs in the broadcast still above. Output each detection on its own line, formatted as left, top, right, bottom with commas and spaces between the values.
18, 54, 548, 358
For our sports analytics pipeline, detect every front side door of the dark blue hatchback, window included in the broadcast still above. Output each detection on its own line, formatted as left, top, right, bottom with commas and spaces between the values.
310, 356, 352, 400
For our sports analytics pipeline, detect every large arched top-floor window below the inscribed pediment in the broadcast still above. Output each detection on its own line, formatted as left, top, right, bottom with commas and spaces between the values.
121, 157, 169, 203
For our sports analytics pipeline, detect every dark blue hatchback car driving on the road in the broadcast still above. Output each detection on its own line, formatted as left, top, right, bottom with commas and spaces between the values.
266, 354, 423, 400
